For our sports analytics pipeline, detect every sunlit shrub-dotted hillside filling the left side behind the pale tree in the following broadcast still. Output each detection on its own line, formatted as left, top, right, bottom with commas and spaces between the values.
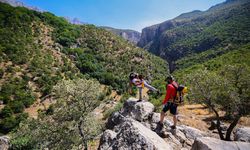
0, 3, 168, 133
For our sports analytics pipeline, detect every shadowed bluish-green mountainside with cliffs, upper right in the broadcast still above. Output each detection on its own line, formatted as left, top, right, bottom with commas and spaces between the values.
139, 0, 250, 72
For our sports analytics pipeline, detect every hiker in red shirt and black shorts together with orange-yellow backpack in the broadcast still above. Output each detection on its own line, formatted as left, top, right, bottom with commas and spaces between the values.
158, 76, 187, 129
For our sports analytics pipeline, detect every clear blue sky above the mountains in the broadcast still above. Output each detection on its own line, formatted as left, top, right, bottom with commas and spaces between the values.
20, 0, 225, 32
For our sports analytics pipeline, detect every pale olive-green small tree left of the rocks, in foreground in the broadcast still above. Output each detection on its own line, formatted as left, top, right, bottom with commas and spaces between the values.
53, 79, 101, 149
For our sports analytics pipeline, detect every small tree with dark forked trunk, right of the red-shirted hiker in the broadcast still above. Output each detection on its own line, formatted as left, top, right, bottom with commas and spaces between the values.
188, 65, 250, 141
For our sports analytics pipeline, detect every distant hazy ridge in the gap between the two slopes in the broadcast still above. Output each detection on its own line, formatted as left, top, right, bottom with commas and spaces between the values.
101, 27, 141, 44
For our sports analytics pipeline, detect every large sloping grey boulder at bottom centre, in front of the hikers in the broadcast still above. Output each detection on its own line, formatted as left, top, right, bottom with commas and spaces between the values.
99, 119, 172, 150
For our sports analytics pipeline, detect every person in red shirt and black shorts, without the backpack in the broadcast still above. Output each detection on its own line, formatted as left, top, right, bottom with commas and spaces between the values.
158, 76, 178, 129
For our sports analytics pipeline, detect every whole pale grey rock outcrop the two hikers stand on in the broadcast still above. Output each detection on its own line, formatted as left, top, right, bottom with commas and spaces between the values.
99, 98, 249, 150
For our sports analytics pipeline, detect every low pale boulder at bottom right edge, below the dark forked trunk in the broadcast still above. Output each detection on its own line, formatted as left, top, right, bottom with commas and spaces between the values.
191, 137, 250, 150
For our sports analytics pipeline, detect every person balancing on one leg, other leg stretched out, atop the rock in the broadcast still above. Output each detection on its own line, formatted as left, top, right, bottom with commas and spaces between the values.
129, 73, 159, 102
